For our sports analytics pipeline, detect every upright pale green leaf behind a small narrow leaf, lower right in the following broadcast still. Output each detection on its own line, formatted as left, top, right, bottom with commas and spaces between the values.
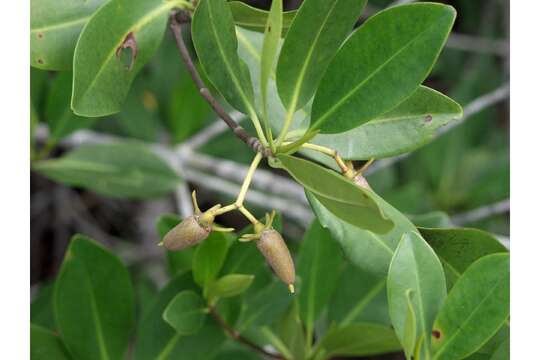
387, 233, 446, 356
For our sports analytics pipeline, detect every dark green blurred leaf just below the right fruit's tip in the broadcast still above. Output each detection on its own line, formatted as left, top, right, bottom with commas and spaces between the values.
237, 280, 293, 333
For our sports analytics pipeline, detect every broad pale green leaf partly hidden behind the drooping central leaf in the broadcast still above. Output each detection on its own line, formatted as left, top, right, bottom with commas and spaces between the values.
306, 192, 416, 278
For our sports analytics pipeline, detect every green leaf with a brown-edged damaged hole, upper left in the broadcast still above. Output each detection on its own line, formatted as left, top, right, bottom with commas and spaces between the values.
71, 0, 176, 117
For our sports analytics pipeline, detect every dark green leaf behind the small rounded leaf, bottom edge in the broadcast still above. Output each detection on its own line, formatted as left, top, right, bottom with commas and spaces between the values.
133, 272, 226, 360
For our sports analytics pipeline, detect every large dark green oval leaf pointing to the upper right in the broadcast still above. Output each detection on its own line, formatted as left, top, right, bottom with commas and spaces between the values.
310, 3, 456, 134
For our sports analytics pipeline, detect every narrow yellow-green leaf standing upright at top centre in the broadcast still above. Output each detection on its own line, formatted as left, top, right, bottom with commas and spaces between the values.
261, 0, 283, 138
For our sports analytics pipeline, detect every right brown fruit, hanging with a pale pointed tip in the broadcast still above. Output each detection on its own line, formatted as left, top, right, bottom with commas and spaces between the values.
256, 229, 295, 291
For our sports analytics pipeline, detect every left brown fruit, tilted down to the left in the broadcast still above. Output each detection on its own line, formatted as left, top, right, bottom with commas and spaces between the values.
163, 215, 212, 251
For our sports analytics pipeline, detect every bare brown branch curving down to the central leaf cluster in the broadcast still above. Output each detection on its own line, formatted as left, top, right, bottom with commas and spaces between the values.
170, 11, 271, 157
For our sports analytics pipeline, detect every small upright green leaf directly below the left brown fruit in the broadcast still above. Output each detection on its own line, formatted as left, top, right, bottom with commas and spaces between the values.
193, 232, 229, 287
